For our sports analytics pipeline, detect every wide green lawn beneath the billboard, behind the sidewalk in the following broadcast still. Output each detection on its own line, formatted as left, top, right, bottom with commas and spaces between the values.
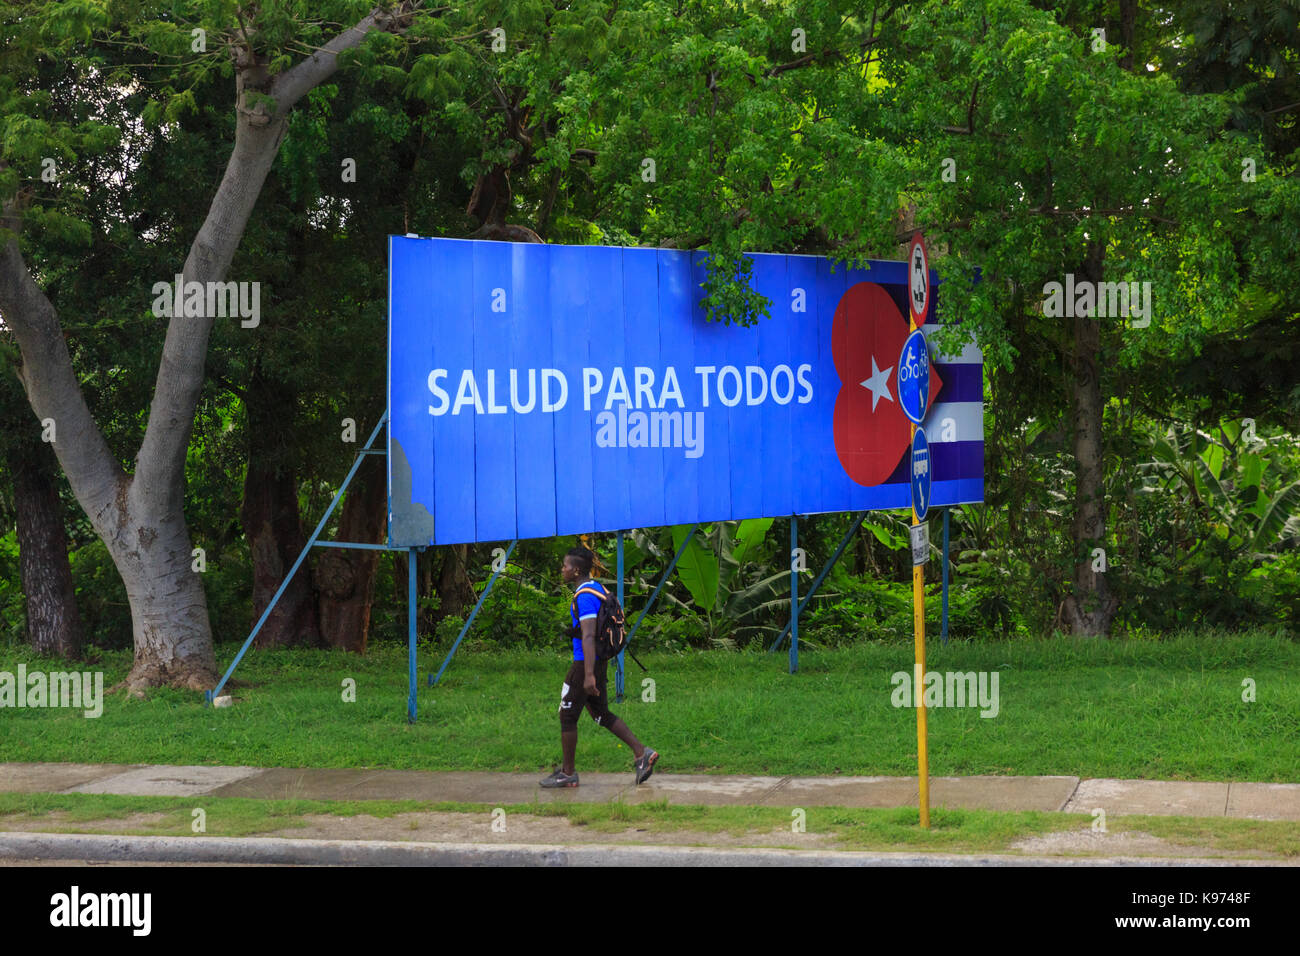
0, 632, 1300, 782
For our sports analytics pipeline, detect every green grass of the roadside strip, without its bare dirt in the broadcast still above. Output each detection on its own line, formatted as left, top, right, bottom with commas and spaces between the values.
0, 793, 1300, 857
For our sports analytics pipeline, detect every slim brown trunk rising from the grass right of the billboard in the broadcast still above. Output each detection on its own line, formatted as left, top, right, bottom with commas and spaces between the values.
1063, 247, 1118, 637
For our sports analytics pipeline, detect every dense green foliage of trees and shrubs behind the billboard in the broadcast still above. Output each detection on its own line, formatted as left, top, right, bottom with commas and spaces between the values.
0, 0, 1300, 660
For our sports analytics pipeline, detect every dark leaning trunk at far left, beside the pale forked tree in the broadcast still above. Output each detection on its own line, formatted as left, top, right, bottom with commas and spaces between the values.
8, 442, 85, 658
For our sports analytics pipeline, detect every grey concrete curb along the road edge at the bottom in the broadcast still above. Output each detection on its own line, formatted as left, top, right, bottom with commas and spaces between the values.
0, 832, 1274, 866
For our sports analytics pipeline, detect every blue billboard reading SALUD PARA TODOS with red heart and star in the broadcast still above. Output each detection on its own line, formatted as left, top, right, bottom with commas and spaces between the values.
389, 237, 984, 548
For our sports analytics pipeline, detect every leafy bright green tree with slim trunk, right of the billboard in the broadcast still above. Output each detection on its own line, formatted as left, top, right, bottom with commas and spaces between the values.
887, 4, 1268, 635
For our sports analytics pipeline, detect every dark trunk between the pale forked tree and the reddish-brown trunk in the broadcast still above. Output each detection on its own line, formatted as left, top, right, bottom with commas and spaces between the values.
239, 368, 321, 648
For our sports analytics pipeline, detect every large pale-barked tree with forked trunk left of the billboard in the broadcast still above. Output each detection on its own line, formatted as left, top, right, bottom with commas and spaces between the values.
0, 1, 431, 692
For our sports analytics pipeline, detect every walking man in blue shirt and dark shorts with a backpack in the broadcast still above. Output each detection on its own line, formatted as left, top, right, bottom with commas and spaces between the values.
542, 548, 659, 790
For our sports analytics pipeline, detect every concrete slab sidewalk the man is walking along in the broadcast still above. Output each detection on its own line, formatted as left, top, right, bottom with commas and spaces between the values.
0, 763, 1300, 821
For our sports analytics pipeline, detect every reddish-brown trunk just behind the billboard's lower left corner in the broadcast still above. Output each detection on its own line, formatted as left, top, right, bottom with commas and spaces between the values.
316, 468, 387, 654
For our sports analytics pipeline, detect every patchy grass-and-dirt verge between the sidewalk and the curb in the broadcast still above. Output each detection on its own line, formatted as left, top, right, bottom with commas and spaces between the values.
0, 793, 1300, 860
